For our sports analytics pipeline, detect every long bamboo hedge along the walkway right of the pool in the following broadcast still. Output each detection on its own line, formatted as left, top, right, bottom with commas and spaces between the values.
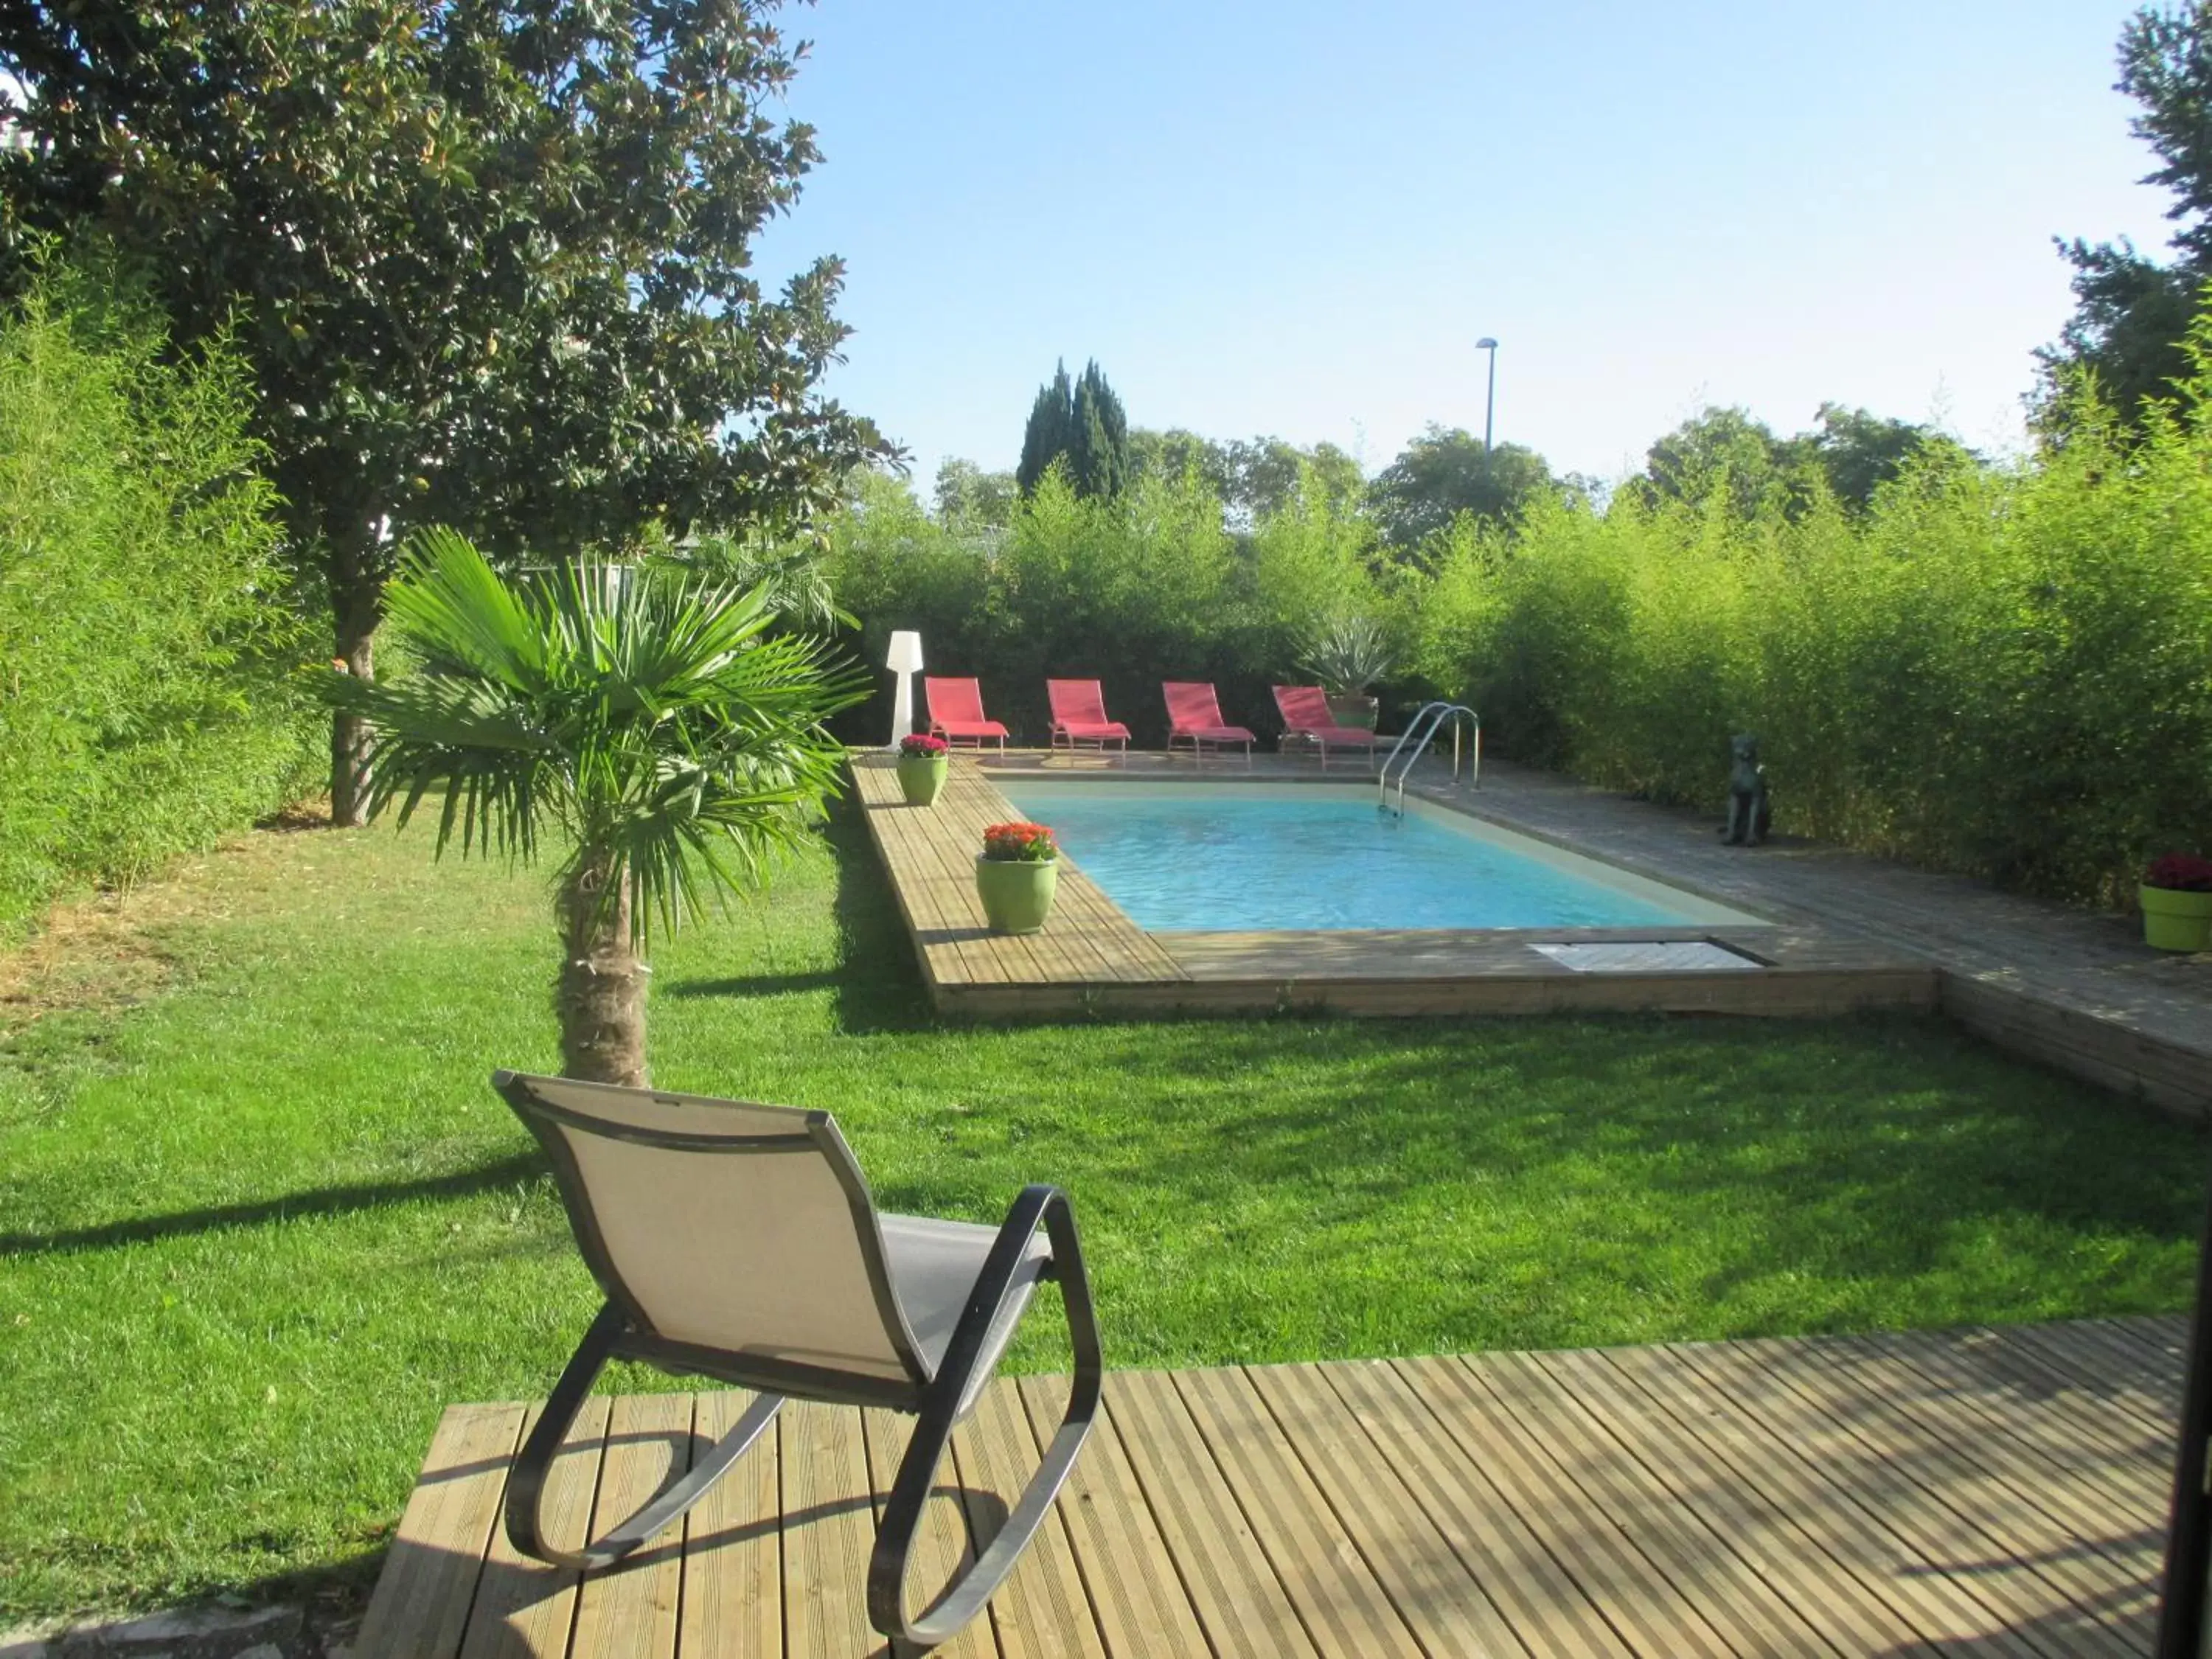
1418, 341, 2212, 902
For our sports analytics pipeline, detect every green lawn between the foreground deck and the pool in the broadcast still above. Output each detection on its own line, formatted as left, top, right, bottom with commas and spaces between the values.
0, 805, 2205, 1617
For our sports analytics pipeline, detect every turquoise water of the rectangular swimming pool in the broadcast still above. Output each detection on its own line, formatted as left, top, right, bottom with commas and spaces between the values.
998, 779, 1761, 931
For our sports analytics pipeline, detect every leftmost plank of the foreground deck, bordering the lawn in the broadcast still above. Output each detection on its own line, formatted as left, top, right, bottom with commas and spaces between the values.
356, 1405, 522, 1659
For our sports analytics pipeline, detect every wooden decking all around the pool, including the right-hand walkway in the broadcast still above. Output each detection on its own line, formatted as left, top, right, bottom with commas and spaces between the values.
854, 750, 2212, 1115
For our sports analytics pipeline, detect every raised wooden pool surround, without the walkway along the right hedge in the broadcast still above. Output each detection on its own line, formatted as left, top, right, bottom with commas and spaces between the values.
849, 750, 1938, 1020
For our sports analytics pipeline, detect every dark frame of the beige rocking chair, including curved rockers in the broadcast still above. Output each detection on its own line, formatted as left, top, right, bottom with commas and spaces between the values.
491, 1071, 1106, 1652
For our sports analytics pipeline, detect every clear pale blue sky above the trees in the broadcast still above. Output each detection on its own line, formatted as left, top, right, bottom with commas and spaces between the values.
759, 0, 2168, 489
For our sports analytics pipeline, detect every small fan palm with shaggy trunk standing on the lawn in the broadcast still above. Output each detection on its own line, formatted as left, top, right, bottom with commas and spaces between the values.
327, 531, 867, 1086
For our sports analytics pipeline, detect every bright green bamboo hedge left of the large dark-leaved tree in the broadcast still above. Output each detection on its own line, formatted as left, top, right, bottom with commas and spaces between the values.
0, 265, 319, 927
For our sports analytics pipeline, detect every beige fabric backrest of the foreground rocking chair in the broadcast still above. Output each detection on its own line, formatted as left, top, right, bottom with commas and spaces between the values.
491, 1071, 929, 1385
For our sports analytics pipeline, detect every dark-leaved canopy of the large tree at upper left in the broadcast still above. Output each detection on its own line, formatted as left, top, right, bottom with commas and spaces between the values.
0, 0, 883, 821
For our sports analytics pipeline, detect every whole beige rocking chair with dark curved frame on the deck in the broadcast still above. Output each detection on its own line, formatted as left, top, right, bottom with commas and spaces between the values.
491, 1071, 1104, 1652
